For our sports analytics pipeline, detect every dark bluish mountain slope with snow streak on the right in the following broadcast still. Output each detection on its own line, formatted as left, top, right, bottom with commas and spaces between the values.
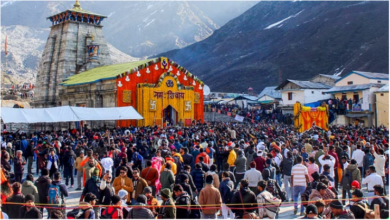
160, 1, 389, 92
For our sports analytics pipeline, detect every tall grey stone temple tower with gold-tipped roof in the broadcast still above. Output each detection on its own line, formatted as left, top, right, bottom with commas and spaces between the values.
33, 1, 111, 108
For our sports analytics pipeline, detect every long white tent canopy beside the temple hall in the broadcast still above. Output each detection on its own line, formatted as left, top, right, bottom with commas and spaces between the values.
0, 106, 143, 123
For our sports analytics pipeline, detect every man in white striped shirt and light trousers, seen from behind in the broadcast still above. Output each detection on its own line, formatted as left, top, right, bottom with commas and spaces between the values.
291, 156, 309, 216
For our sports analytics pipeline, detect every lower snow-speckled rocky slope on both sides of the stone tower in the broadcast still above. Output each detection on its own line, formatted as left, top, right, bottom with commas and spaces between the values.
1, 25, 138, 84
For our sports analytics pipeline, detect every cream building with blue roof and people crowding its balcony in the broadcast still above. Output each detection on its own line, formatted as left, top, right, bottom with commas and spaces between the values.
326, 71, 389, 126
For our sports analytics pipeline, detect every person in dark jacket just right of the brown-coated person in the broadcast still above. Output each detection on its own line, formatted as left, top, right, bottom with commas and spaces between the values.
219, 171, 234, 219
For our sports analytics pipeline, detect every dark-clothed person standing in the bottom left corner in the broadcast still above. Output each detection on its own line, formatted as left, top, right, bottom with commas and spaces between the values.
2, 182, 24, 219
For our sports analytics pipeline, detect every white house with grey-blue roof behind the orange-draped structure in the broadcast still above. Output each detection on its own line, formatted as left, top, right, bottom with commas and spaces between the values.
275, 79, 332, 114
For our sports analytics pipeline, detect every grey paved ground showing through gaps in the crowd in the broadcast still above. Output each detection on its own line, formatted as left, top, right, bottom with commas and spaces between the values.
23, 162, 389, 219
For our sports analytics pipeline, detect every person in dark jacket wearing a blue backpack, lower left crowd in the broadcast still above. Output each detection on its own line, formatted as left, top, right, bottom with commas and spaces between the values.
47, 172, 68, 216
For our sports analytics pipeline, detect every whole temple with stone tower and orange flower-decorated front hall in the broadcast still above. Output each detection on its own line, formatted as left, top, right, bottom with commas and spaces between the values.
34, 1, 204, 126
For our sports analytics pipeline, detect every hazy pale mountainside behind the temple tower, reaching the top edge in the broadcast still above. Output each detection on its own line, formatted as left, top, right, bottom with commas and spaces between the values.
1, 1, 256, 82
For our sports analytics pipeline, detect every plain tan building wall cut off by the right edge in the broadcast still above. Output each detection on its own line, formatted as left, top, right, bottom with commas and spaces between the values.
375, 84, 389, 128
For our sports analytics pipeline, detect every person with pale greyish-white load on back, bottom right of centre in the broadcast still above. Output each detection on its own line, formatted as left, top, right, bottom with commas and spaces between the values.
256, 180, 282, 219
